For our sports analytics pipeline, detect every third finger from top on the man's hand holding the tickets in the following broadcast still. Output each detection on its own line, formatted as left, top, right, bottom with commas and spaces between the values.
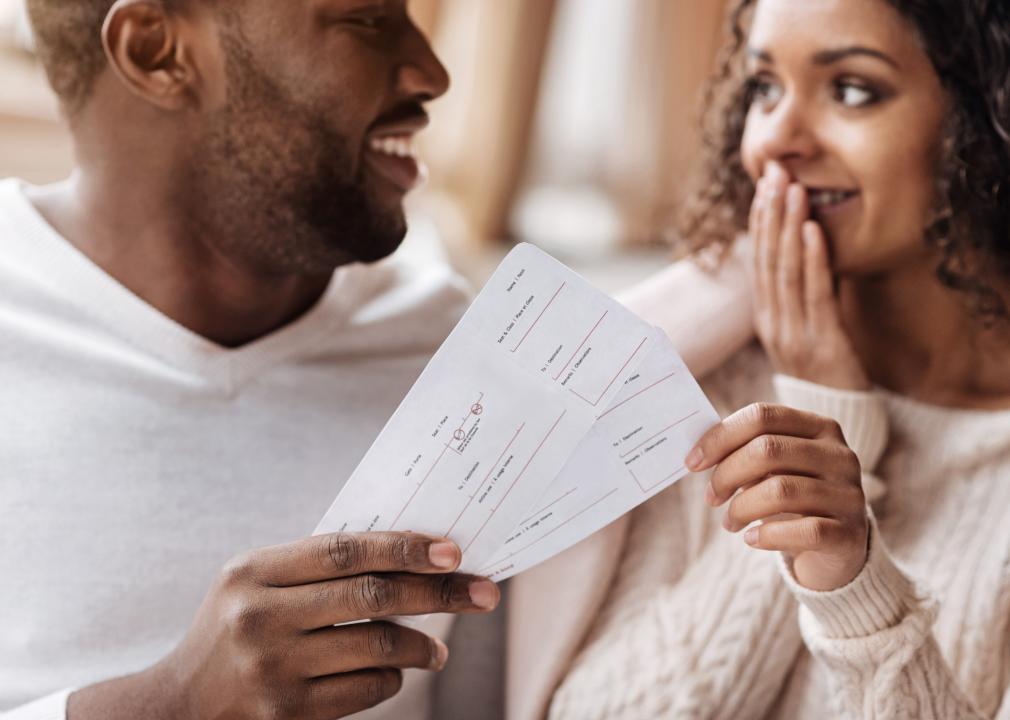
299, 622, 448, 679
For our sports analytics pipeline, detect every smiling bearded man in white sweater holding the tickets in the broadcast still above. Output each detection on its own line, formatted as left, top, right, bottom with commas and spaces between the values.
0, 0, 498, 720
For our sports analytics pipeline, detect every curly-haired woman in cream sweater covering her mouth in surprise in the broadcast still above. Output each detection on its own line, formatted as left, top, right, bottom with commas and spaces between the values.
510, 0, 1010, 720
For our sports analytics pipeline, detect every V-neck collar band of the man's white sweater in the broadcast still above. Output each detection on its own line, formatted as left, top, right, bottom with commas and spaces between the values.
0, 180, 367, 394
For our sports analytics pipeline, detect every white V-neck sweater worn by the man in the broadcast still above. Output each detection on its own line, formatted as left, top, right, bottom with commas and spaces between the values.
0, 181, 467, 720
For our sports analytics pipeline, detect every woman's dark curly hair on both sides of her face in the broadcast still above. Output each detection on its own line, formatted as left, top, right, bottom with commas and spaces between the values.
681, 0, 1010, 326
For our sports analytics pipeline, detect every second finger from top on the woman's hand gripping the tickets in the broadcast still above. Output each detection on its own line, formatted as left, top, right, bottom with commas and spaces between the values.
711, 435, 859, 505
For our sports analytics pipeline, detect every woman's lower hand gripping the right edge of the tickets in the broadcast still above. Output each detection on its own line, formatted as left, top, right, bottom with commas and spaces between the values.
686, 403, 870, 591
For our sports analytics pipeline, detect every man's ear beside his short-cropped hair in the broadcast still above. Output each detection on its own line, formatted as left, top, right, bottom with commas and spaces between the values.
102, 0, 197, 110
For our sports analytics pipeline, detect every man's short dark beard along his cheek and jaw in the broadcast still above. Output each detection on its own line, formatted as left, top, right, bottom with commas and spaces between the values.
187, 30, 406, 275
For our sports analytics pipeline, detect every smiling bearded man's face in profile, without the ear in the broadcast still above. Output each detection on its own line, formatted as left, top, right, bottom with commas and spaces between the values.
182, 0, 448, 275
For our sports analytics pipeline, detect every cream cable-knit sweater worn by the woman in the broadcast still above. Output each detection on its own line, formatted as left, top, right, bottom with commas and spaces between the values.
550, 346, 1010, 720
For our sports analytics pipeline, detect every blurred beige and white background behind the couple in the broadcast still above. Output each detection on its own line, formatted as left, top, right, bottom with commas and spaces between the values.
0, 0, 727, 292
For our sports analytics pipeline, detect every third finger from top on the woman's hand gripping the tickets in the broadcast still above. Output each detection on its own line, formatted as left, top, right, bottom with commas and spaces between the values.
723, 475, 865, 532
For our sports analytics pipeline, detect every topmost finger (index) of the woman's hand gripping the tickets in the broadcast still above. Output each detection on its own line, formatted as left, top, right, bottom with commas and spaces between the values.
685, 403, 842, 473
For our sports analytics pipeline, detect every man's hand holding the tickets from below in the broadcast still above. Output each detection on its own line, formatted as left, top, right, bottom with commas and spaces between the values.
69, 532, 499, 720
